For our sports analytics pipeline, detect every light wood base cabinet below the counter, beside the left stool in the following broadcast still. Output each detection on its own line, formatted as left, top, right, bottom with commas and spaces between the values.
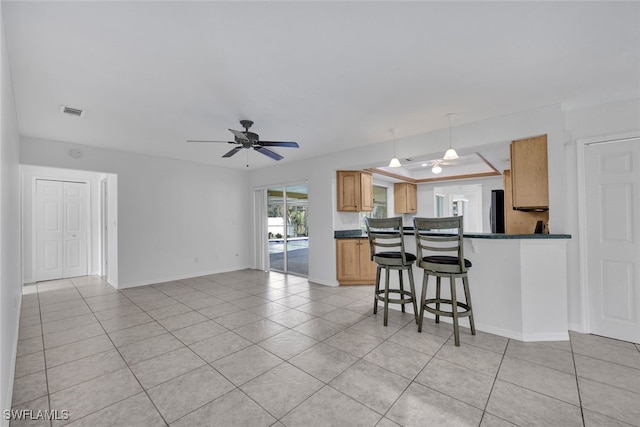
336, 238, 377, 285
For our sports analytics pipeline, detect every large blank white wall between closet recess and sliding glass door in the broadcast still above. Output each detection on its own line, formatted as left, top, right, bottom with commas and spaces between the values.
20, 138, 252, 288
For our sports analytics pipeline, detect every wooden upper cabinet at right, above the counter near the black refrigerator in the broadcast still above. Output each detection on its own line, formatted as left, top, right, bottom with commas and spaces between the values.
511, 135, 549, 209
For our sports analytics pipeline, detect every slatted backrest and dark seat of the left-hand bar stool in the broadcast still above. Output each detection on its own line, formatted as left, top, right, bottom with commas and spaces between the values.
364, 217, 407, 265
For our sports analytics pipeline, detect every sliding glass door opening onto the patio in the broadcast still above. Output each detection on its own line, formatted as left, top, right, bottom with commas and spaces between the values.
267, 183, 309, 277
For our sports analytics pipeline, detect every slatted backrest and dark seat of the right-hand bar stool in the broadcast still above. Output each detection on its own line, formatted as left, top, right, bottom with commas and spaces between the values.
413, 216, 467, 274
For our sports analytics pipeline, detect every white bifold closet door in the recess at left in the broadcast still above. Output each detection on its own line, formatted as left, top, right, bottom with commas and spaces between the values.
36, 179, 88, 281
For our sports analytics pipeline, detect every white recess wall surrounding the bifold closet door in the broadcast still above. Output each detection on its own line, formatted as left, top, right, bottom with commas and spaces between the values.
22, 165, 106, 283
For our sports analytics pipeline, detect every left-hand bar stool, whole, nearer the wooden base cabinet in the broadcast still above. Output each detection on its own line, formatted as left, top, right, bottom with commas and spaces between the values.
365, 217, 418, 326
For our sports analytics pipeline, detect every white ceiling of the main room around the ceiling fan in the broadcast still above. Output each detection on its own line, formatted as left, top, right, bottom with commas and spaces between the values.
2, 1, 640, 168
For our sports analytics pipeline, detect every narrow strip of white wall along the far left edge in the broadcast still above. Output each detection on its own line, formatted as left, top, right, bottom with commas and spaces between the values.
0, 2, 22, 426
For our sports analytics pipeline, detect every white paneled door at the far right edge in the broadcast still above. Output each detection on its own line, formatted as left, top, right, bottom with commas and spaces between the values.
585, 139, 640, 342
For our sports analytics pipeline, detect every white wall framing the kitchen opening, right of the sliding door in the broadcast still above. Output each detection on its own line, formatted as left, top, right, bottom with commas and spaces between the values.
250, 105, 567, 285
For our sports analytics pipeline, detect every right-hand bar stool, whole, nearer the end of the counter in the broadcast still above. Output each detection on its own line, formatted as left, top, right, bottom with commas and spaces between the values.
413, 216, 476, 346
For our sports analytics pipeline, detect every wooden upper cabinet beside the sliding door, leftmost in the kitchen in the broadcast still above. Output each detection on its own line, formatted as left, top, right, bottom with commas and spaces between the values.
337, 171, 373, 212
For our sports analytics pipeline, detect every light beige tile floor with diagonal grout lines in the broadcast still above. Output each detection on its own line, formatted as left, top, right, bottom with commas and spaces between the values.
11, 270, 640, 426
